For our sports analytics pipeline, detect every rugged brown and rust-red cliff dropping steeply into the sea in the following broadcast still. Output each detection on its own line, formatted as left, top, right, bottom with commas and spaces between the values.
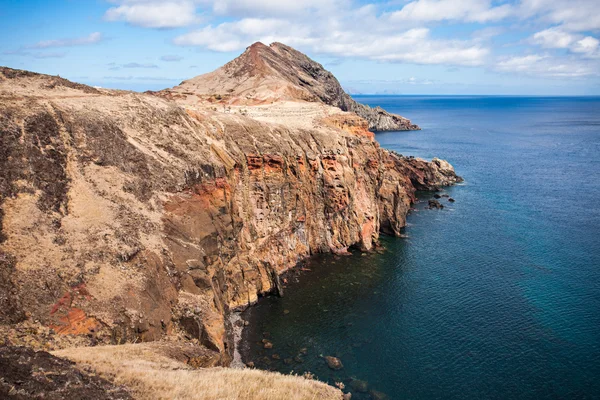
0, 54, 460, 365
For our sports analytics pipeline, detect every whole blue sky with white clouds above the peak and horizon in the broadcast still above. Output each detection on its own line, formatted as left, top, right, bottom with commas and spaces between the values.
0, 0, 600, 95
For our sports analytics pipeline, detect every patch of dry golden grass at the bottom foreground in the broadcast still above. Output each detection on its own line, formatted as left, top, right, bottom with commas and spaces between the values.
54, 344, 342, 400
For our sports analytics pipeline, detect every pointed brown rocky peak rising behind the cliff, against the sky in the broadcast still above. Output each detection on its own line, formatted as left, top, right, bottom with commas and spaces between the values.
165, 42, 419, 131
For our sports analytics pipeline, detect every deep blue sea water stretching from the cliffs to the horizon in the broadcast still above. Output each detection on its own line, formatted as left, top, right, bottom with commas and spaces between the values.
242, 96, 600, 399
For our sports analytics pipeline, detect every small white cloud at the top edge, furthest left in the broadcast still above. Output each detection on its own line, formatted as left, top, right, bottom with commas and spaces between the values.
104, 0, 199, 28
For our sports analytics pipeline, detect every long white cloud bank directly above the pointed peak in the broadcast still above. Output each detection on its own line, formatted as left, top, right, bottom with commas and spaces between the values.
174, 18, 489, 65
